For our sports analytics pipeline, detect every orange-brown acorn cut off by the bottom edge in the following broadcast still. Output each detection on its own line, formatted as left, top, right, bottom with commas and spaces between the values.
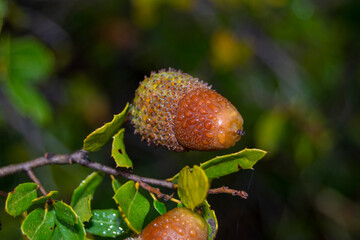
141, 207, 208, 240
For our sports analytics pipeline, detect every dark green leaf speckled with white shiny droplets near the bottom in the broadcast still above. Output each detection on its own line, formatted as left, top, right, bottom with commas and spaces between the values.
86, 209, 129, 237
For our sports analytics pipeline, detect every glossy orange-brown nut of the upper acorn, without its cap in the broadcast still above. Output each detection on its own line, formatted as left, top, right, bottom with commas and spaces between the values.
174, 88, 244, 151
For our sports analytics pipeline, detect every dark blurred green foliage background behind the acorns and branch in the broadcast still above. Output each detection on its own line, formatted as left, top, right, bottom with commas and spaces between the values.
0, 0, 360, 240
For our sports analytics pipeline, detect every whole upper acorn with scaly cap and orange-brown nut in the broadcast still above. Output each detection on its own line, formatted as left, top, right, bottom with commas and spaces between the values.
131, 68, 244, 152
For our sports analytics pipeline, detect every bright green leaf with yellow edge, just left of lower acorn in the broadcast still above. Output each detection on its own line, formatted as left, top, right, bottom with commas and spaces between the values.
114, 181, 150, 233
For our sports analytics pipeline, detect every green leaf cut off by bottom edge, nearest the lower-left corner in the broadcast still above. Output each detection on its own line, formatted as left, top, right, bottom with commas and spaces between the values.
21, 208, 55, 240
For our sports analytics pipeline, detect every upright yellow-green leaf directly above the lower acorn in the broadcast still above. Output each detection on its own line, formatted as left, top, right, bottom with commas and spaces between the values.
178, 165, 210, 210
